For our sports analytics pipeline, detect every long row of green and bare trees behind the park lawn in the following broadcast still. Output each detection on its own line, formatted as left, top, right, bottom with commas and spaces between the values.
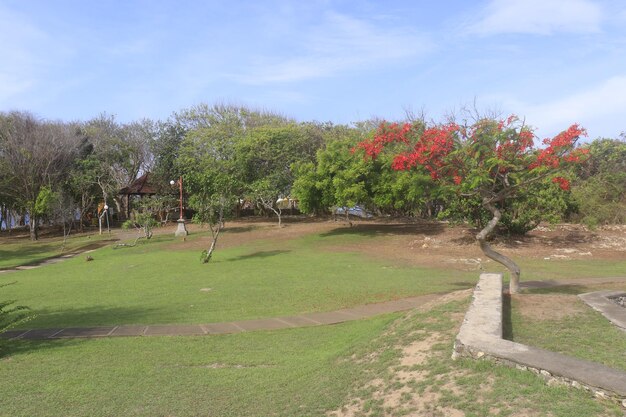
0, 104, 626, 239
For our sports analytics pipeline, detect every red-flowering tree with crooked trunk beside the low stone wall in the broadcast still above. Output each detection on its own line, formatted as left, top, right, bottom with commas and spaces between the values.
356, 116, 587, 293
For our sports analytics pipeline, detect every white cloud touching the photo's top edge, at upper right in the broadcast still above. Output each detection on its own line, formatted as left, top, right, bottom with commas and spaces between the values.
468, 0, 603, 35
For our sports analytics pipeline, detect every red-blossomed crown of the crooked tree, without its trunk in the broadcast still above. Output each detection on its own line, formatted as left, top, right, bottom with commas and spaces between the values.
353, 116, 588, 190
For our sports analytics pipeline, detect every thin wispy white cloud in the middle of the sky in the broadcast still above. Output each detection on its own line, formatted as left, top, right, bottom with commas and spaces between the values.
233, 13, 432, 84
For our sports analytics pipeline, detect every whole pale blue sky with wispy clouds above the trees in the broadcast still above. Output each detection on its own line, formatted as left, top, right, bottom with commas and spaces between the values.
0, 0, 626, 139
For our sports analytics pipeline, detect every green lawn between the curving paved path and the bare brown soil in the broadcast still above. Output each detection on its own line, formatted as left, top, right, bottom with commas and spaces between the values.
0, 228, 477, 328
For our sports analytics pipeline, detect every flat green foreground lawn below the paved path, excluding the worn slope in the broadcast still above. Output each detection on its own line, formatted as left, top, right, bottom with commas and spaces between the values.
0, 316, 395, 417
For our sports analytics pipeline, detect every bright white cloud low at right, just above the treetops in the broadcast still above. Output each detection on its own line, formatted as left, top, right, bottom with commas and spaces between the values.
507, 75, 626, 139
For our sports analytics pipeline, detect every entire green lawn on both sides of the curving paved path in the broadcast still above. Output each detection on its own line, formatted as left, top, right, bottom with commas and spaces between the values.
0, 223, 625, 417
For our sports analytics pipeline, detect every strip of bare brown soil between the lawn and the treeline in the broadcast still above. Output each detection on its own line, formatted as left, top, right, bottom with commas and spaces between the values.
166, 219, 626, 273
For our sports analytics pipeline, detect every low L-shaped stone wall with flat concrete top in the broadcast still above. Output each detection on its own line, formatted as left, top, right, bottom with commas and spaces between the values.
452, 274, 626, 408
